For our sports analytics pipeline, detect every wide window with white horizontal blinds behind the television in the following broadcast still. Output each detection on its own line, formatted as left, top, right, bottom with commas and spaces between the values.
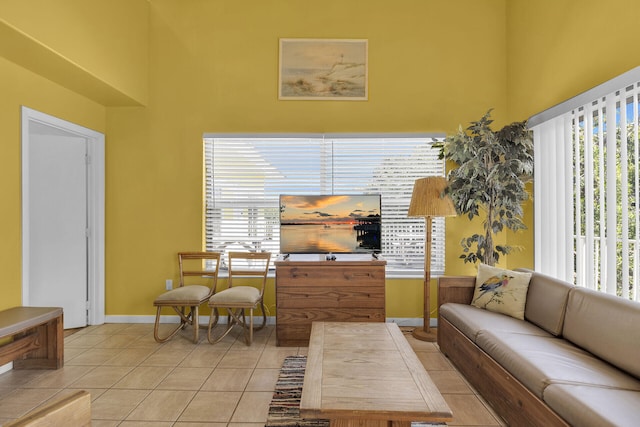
204, 135, 445, 275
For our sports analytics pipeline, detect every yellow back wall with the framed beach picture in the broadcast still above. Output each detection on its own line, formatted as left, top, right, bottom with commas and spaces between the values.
106, 0, 506, 317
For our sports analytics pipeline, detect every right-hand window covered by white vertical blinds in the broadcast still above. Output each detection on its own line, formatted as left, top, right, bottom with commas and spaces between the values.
529, 67, 640, 301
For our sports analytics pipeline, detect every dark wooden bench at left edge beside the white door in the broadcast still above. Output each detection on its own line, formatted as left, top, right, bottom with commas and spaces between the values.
0, 307, 64, 369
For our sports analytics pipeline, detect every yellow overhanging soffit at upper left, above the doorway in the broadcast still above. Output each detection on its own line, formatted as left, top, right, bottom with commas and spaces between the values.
0, 0, 149, 106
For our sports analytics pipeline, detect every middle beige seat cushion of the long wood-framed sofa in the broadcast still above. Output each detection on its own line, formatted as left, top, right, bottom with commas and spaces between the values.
476, 330, 640, 398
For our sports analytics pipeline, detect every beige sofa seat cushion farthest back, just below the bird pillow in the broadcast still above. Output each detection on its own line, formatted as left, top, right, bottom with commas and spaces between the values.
440, 303, 551, 342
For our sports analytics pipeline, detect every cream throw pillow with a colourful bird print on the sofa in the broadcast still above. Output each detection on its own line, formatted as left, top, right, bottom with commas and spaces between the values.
471, 264, 532, 320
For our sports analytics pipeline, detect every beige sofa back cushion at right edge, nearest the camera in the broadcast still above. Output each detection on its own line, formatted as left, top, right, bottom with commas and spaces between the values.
562, 287, 640, 378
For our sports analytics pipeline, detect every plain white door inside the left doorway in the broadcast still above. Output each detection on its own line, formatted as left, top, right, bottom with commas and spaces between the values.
28, 130, 88, 328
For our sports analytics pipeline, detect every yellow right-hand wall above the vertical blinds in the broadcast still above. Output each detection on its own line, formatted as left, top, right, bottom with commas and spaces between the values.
507, 0, 640, 274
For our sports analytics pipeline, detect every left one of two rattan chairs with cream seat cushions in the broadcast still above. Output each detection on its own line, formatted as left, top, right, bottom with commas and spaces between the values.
153, 252, 220, 344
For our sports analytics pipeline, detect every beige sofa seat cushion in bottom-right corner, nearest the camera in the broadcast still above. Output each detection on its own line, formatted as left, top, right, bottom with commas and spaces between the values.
544, 384, 640, 427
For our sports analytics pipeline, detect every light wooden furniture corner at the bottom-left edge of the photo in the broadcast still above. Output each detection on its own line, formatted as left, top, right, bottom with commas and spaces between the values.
4, 390, 91, 427
